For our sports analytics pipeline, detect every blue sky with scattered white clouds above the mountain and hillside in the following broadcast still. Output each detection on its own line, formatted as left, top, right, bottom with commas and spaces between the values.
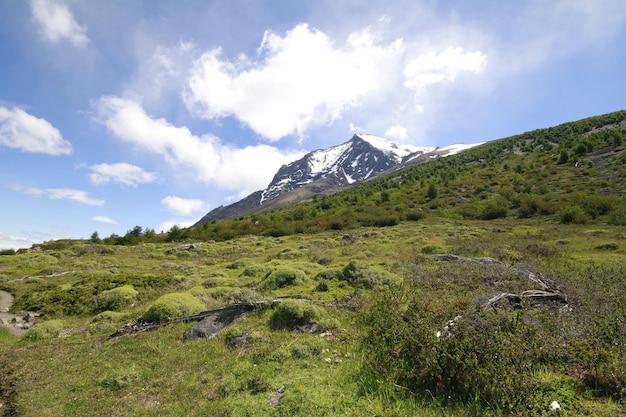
0, 0, 626, 248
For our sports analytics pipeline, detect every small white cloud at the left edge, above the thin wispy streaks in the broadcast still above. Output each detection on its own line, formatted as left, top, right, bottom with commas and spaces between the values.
0, 106, 72, 155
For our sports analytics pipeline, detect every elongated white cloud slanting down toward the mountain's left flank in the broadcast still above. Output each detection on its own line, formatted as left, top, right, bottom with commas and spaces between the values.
95, 97, 302, 196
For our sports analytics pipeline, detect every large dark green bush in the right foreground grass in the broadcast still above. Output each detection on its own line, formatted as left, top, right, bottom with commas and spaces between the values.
362, 294, 541, 414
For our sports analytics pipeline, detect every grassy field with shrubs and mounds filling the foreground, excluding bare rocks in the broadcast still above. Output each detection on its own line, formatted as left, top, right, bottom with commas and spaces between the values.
0, 217, 626, 416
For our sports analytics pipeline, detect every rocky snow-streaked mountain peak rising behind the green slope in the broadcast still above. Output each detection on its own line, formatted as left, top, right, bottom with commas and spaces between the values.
194, 133, 475, 226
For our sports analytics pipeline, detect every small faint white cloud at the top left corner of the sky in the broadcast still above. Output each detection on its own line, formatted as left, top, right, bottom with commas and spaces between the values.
30, 0, 89, 47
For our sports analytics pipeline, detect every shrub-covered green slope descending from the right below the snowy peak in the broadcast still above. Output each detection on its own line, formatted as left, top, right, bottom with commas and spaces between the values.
177, 111, 626, 239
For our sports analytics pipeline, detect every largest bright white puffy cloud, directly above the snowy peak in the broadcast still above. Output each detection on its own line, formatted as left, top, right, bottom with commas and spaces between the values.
185, 24, 403, 140
